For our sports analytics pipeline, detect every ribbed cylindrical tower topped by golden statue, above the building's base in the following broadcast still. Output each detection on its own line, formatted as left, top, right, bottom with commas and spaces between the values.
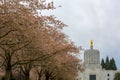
84, 40, 101, 68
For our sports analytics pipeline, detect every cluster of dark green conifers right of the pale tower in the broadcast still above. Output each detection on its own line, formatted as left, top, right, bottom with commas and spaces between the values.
101, 56, 117, 70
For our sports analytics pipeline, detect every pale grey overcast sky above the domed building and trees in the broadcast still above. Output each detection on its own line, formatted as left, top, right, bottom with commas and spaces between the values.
45, 0, 120, 68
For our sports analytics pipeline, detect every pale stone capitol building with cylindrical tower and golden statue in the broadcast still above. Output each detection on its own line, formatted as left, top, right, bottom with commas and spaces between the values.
76, 40, 120, 80
